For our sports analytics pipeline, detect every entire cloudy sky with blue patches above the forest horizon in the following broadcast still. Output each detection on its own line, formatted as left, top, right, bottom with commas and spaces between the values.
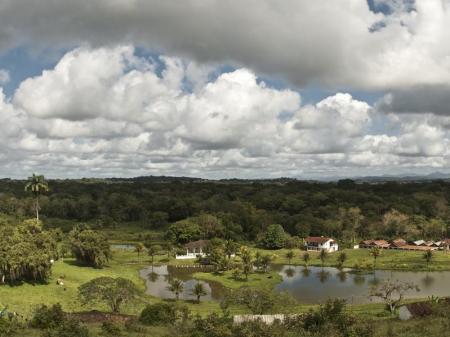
0, 0, 450, 179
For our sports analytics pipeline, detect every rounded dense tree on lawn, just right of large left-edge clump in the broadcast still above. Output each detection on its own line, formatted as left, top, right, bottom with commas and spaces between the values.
69, 226, 111, 268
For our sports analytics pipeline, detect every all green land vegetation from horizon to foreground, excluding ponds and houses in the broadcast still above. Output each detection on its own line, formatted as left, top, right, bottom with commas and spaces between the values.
0, 175, 450, 337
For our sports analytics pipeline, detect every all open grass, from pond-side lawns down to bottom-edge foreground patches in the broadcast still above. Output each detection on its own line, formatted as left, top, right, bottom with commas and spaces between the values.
0, 243, 450, 337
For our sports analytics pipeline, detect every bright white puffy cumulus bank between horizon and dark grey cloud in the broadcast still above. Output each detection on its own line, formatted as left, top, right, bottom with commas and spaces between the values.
0, 45, 450, 178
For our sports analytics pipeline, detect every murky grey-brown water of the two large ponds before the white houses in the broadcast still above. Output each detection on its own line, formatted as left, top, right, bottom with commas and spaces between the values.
140, 265, 450, 304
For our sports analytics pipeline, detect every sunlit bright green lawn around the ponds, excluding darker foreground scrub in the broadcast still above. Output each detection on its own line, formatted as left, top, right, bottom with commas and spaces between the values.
0, 236, 450, 316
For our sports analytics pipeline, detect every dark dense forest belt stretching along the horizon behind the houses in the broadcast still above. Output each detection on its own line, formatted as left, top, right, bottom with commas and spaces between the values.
0, 177, 450, 240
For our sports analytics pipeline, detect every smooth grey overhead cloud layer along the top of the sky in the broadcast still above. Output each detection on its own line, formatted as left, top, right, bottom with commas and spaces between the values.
0, 0, 450, 90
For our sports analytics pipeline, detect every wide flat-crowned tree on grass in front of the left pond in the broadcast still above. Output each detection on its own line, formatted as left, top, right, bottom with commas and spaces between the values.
78, 276, 141, 313
